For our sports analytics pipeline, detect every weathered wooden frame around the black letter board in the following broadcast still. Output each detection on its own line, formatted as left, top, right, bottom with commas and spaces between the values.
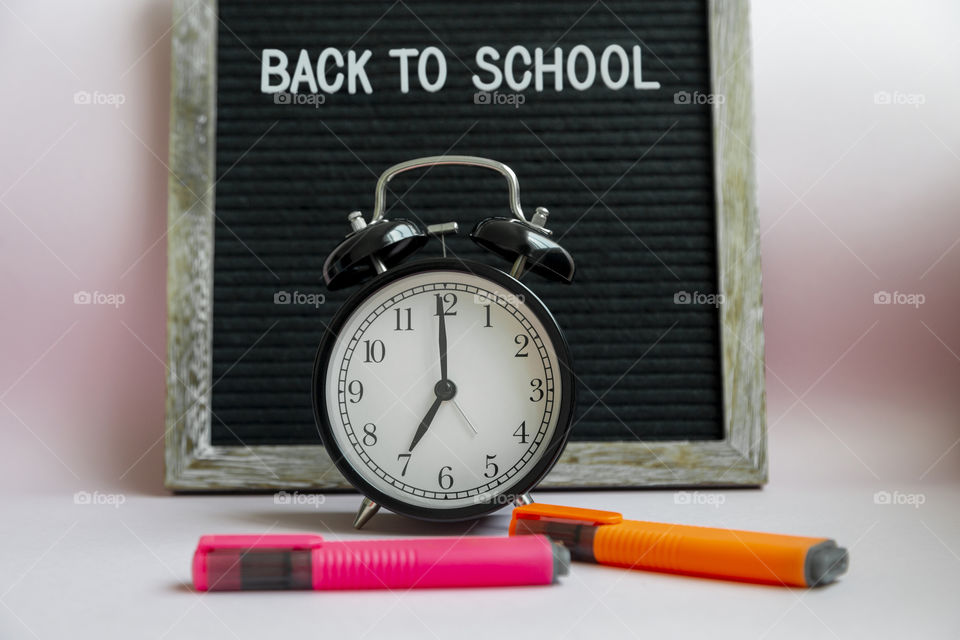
165, 0, 767, 491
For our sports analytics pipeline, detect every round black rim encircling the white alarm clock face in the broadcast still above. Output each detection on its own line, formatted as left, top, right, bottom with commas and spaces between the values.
311, 258, 576, 522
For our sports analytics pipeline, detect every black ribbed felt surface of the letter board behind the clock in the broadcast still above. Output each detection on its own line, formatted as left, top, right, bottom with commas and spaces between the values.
212, 0, 722, 445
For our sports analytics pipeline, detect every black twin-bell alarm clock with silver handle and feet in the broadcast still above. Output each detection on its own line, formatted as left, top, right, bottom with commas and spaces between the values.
313, 156, 575, 528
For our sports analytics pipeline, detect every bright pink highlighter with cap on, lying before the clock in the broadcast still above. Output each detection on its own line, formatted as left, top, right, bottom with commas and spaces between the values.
193, 535, 570, 591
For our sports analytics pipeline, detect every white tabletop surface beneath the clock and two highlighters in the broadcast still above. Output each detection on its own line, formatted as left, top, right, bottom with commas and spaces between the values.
0, 458, 960, 640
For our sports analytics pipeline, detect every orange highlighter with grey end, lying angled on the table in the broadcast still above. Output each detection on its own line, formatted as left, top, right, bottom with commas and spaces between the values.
510, 503, 848, 587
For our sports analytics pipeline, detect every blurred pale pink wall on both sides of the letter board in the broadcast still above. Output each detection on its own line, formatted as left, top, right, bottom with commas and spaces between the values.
0, 0, 960, 493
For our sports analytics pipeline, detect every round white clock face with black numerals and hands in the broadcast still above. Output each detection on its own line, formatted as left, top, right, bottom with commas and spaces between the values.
323, 270, 564, 509
